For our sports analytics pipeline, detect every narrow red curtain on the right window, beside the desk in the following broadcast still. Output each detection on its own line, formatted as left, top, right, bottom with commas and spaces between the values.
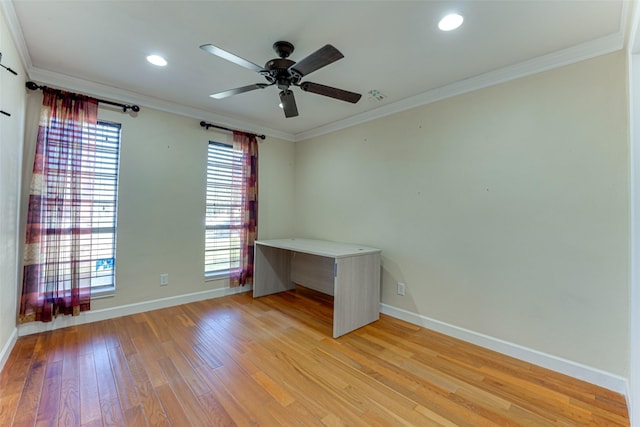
229, 132, 258, 287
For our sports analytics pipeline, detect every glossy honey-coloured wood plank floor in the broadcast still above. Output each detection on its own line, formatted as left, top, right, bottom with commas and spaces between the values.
0, 288, 629, 426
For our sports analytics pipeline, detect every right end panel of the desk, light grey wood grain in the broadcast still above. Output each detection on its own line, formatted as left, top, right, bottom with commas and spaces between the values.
333, 253, 380, 338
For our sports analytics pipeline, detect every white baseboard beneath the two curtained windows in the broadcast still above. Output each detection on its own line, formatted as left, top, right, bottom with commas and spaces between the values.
17, 286, 253, 336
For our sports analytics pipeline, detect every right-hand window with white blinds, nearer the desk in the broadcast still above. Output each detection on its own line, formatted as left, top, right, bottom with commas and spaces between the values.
204, 141, 243, 276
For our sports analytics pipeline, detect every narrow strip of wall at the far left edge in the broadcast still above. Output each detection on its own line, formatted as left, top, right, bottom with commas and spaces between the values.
0, 3, 25, 368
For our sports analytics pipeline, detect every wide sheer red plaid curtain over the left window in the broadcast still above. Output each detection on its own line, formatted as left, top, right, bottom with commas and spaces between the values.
19, 89, 98, 323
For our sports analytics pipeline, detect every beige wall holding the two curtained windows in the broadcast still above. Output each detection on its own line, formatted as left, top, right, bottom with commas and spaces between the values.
15, 92, 294, 310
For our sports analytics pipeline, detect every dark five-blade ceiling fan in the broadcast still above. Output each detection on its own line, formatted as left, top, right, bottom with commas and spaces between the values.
200, 41, 362, 117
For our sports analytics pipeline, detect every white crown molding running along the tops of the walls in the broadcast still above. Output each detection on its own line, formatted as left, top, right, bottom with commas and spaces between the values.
5, 0, 640, 145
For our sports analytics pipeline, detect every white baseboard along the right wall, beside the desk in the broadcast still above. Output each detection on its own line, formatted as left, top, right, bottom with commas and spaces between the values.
380, 304, 629, 397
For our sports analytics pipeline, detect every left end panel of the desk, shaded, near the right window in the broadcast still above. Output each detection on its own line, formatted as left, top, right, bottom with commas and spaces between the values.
253, 245, 295, 298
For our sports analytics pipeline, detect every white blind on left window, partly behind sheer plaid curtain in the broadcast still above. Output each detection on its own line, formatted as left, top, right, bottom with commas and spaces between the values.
43, 122, 120, 291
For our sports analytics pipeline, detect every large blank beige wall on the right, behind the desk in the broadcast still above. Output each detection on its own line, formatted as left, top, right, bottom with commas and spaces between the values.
295, 52, 629, 376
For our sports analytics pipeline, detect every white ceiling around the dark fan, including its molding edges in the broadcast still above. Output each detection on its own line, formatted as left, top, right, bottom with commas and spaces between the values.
2, 0, 630, 140
